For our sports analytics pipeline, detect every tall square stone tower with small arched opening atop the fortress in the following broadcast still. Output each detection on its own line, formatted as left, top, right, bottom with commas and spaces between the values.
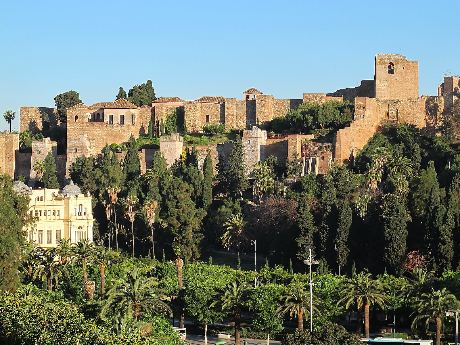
375, 54, 418, 100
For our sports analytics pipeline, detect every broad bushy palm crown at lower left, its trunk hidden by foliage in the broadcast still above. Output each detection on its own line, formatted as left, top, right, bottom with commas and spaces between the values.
101, 268, 171, 322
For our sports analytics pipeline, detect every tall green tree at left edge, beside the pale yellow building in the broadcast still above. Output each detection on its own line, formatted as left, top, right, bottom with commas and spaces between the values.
0, 174, 30, 291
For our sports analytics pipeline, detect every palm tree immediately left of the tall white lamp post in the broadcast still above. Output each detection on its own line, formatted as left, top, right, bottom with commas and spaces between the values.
280, 281, 318, 331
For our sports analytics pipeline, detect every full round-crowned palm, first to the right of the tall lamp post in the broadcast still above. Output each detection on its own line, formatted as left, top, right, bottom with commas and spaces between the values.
339, 272, 386, 338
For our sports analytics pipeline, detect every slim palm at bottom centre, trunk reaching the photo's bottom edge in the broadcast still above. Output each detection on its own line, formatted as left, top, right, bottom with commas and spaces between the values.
213, 281, 249, 345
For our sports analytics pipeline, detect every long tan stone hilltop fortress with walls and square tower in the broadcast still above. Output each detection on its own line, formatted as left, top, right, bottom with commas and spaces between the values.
0, 54, 460, 180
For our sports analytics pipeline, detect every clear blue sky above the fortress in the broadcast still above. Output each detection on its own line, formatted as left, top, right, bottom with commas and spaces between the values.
0, 0, 460, 130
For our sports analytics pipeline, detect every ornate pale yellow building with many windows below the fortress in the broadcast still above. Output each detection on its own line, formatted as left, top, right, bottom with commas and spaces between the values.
15, 182, 94, 248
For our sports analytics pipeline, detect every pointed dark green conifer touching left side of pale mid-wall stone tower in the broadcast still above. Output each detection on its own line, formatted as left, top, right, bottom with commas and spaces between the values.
218, 138, 249, 198
